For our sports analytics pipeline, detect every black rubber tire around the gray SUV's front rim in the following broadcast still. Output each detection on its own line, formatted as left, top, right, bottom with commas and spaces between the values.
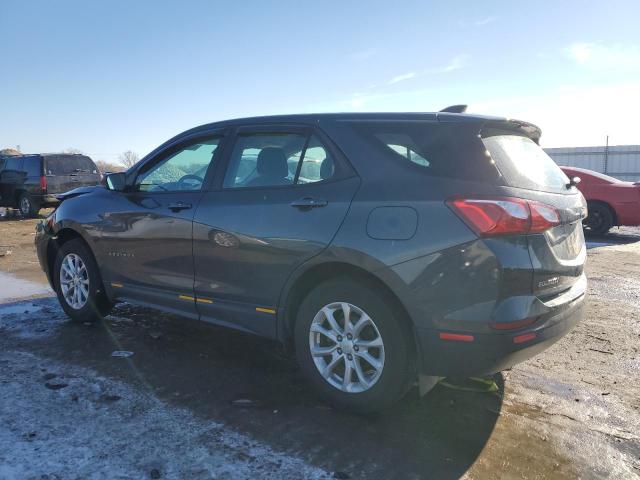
52, 238, 113, 322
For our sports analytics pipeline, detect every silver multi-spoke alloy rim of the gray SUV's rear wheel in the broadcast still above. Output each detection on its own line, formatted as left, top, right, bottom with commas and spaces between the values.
309, 302, 385, 393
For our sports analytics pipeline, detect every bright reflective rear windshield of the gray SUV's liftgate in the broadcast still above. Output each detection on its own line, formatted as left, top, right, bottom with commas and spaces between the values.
482, 133, 569, 193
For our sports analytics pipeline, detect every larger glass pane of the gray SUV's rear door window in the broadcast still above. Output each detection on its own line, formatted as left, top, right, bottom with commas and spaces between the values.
223, 133, 306, 188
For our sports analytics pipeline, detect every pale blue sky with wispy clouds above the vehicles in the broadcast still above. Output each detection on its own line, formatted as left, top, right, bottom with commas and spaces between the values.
0, 0, 640, 164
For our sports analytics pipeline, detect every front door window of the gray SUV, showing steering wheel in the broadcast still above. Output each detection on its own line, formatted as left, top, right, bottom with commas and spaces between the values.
135, 138, 220, 192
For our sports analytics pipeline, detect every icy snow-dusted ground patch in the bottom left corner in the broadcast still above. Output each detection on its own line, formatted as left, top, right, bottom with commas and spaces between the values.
0, 351, 330, 480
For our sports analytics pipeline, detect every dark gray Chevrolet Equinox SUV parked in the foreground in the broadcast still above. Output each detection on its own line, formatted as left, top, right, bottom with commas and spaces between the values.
36, 112, 586, 411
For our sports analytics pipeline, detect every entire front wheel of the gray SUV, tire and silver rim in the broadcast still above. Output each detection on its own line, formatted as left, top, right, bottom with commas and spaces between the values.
52, 239, 113, 322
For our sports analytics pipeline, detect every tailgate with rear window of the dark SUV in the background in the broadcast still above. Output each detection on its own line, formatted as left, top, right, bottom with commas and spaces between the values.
44, 154, 100, 194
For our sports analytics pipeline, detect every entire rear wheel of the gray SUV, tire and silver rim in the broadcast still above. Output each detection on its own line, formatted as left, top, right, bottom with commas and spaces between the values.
295, 278, 415, 413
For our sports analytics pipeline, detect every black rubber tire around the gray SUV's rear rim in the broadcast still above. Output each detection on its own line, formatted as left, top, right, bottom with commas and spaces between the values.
295, 278, 415, 413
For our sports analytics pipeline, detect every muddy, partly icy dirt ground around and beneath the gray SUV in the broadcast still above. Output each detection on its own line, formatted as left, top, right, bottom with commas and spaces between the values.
0, 214, 640, 479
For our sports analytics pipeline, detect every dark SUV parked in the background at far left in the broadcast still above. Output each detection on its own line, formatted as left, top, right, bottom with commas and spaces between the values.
0, 153, 101, 217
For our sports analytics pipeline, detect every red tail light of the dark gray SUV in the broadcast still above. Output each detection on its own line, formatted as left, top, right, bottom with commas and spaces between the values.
447, 197, 560, 237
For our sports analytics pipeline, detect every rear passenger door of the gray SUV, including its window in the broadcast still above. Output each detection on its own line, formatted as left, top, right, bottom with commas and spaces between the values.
193, 126, 359, 336
